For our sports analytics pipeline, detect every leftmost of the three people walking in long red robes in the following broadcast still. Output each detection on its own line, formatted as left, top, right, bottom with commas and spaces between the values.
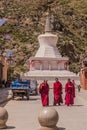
39, 80, 49, 106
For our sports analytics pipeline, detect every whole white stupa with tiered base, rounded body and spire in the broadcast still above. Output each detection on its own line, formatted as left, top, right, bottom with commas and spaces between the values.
22, 15, 78, 83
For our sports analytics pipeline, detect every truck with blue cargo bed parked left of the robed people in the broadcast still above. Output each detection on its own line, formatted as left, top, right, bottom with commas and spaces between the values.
10, 80, 38, 100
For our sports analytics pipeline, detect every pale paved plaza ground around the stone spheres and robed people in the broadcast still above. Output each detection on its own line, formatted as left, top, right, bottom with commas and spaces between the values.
0, 89, 87, 130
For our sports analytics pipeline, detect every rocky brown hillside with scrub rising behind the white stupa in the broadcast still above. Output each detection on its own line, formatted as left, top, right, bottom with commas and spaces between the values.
0, 0, 87, 76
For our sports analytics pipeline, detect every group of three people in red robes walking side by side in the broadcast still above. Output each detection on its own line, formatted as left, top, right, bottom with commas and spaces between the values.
39, 78, 75, 106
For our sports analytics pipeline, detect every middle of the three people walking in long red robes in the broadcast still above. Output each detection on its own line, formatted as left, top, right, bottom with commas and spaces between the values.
53, 78, 63, 105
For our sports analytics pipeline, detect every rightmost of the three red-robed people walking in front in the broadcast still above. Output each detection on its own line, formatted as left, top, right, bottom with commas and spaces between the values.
65, 79, 75, 106
